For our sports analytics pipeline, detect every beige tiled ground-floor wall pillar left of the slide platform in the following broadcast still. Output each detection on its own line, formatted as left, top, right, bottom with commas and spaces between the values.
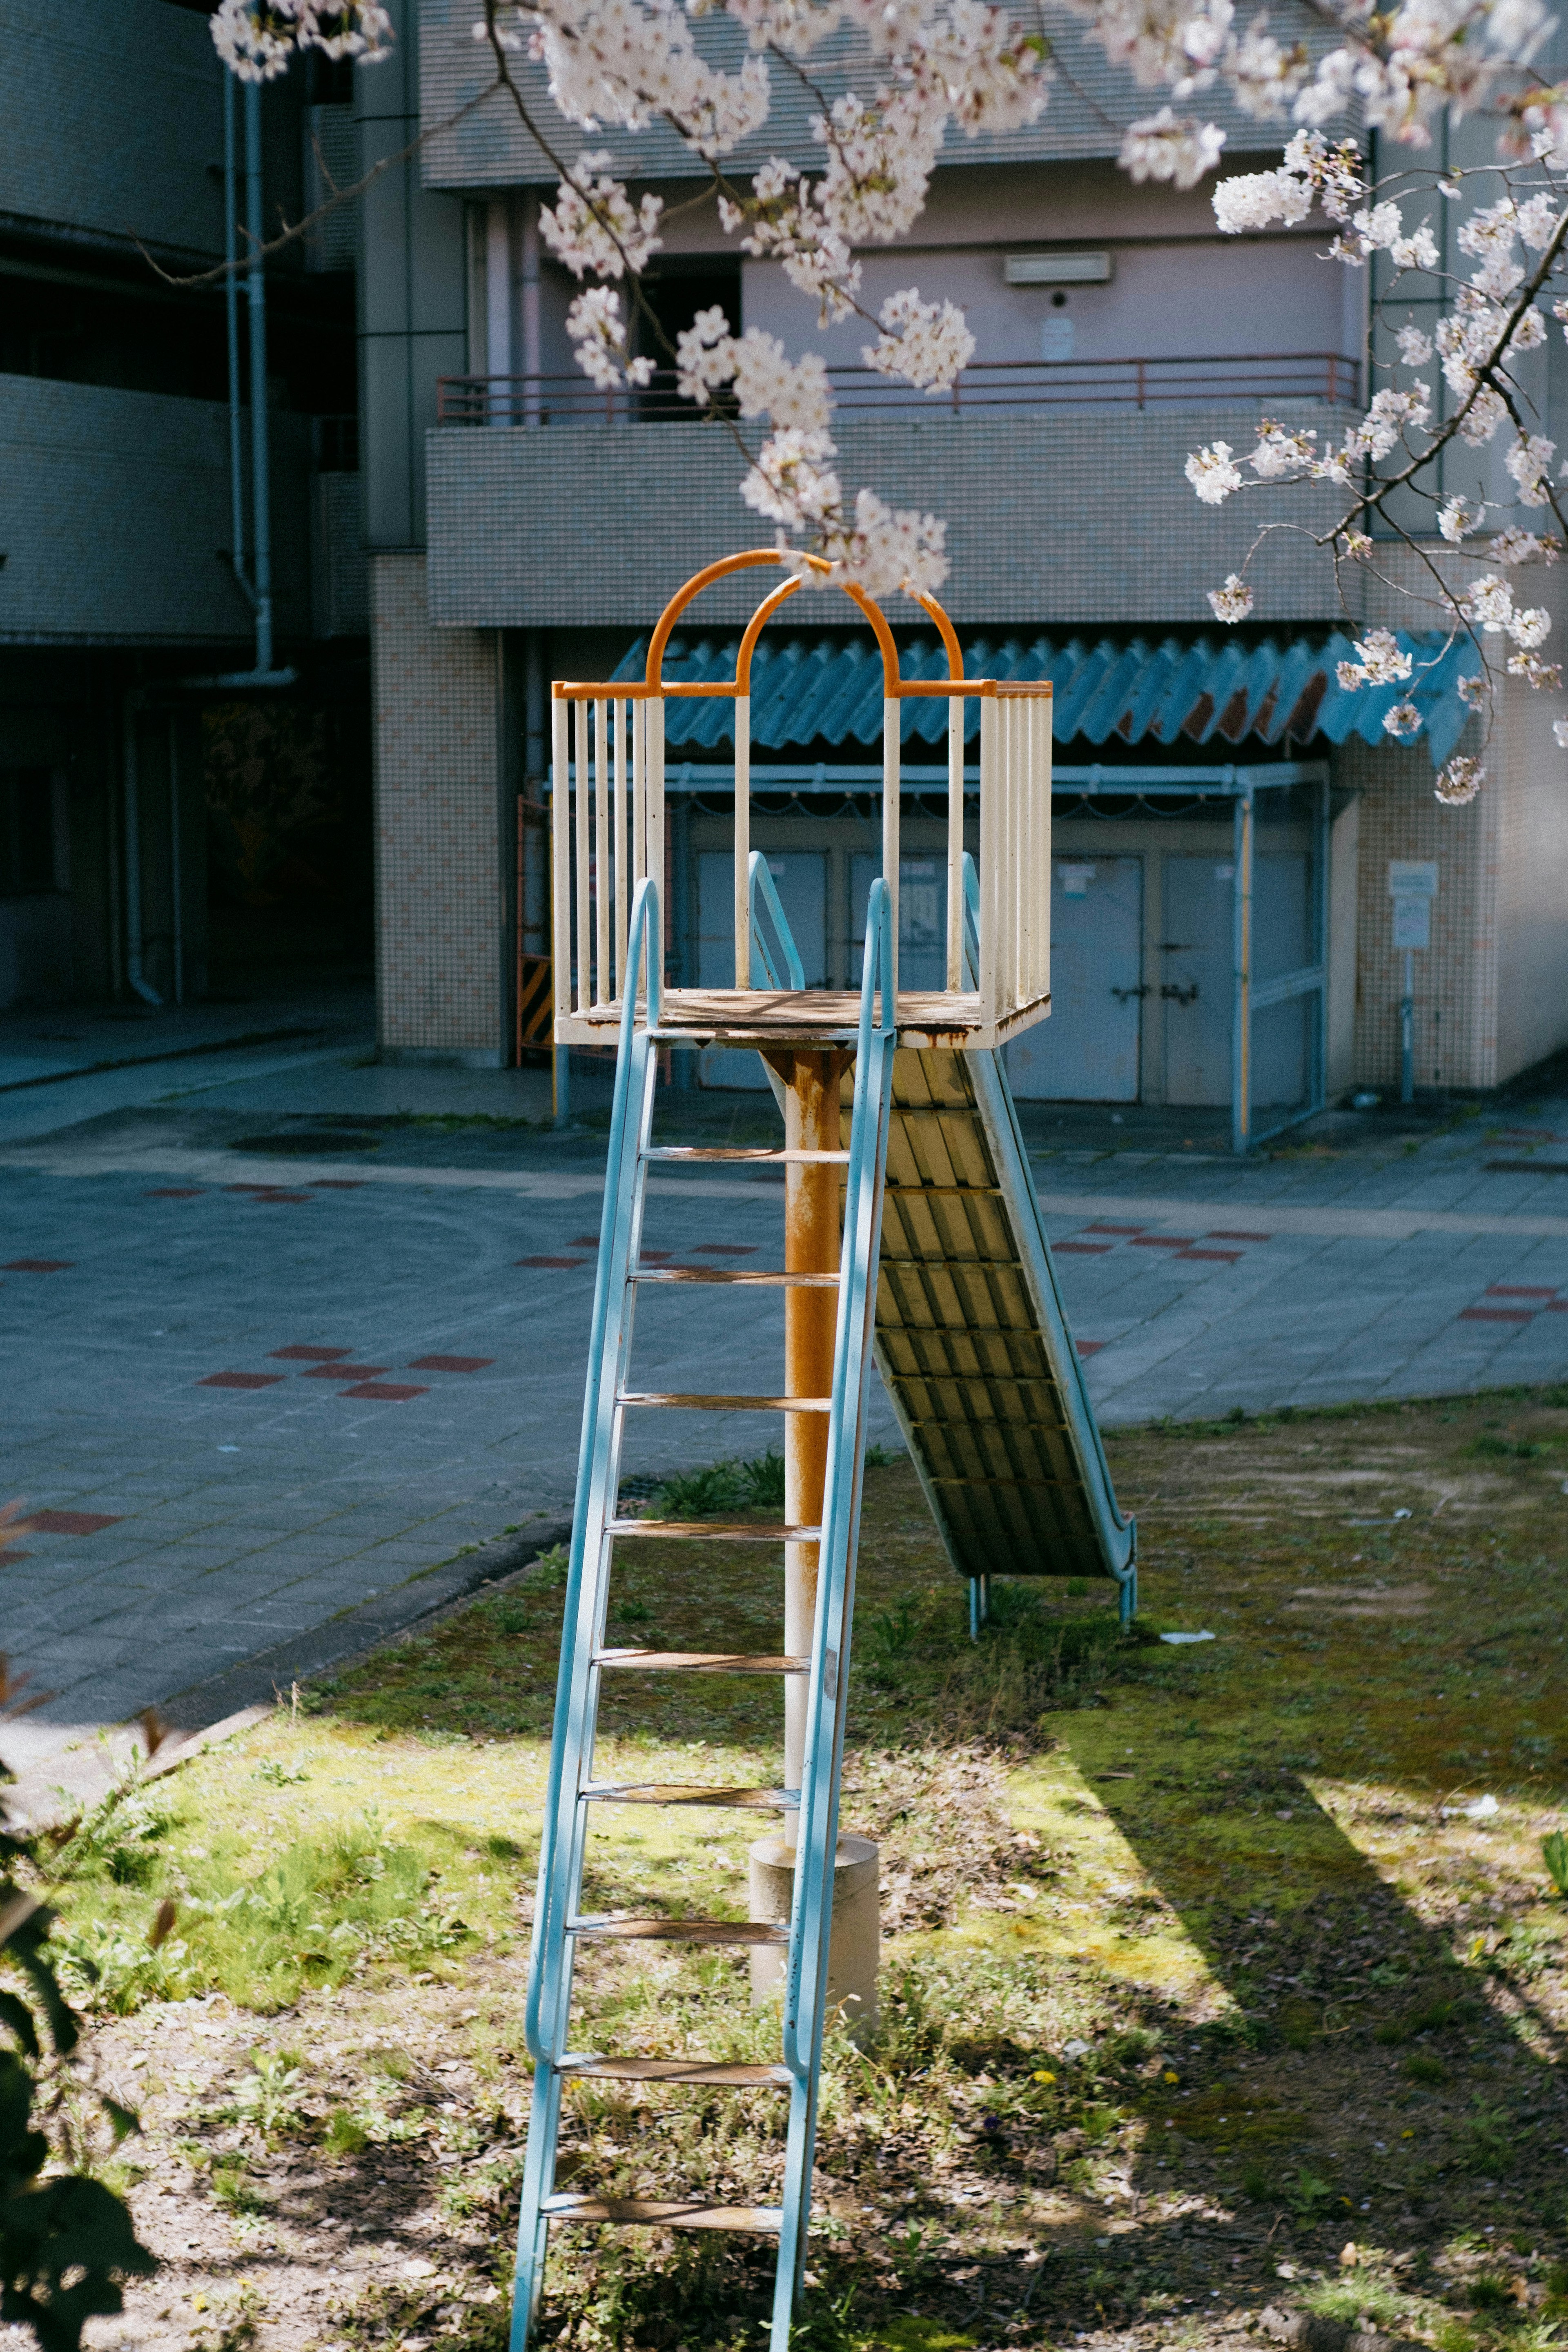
372, 555, 506, 1068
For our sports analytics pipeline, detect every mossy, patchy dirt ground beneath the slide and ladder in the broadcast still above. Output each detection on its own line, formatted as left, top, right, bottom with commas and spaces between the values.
12, 1392, 1568, 2352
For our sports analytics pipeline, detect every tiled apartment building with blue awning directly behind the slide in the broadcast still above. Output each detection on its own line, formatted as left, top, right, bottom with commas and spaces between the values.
357, 0, 1568, 1143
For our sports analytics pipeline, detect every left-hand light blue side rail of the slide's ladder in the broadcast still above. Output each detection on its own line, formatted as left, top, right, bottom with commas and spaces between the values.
510, 880, 661, 2352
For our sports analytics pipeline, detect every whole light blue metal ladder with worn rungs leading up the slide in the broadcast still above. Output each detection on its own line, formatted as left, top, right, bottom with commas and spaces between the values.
512, 861, 898, 2352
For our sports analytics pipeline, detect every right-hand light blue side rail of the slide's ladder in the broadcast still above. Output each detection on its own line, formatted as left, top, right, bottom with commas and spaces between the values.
771, 877, 898, 2352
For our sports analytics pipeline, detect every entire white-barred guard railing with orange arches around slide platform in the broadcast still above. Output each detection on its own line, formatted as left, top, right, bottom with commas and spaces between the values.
550, 550, 1051, 1044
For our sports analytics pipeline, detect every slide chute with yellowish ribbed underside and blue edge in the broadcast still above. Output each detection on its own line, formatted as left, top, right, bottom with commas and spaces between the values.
877, 1049, 1138, 1623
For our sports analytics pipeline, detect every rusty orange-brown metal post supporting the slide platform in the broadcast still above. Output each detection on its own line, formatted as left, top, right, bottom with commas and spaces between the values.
776, 1051, 849, 1844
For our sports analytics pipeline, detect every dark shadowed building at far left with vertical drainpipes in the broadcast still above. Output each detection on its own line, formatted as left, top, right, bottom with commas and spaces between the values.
0, 0, 372, 1011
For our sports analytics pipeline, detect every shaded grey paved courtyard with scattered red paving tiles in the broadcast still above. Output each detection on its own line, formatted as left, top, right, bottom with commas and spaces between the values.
0, 1033, 1568, 1762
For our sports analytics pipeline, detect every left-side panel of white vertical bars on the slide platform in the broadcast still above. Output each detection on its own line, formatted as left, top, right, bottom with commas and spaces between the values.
550, 684, 665, 1025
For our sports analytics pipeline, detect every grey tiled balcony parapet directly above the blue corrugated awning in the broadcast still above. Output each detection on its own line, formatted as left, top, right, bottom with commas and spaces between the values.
425, 402, 1345, 628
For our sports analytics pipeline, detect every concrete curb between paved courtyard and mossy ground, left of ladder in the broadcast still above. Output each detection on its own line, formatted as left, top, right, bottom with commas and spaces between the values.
5, 1519, 571, 1830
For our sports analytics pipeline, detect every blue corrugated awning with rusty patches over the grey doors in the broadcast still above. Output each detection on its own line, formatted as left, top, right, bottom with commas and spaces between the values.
614, 630, 1481, 767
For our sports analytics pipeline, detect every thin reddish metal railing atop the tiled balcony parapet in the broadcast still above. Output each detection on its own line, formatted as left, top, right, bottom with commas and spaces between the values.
437, 350, 1361, 428
